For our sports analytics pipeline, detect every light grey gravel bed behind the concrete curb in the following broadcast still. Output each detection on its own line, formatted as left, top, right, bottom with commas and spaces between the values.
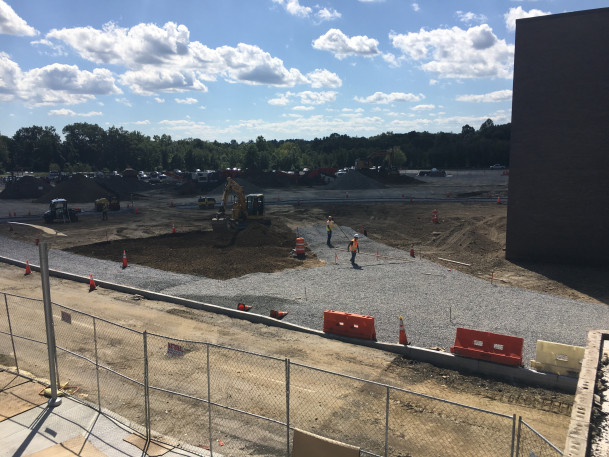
0, 226, 609, 366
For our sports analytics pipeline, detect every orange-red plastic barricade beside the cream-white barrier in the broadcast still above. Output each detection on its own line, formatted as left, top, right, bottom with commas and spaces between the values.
450, 327, 524, 366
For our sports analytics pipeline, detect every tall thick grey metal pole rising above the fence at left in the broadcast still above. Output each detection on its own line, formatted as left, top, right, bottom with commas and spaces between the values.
38, 242, 61, 407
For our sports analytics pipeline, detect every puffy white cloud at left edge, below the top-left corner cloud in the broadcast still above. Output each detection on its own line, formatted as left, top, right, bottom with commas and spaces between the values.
0, 52, 122, 106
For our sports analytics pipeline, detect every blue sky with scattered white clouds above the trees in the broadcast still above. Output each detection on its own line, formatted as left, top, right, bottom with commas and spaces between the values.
0, 0, 609, 142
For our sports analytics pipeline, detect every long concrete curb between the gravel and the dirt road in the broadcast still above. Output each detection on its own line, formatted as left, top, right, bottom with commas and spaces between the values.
0, 256, 578, 393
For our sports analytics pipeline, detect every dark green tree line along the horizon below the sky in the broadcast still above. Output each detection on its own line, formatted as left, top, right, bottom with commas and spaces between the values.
0, 119, 510, 173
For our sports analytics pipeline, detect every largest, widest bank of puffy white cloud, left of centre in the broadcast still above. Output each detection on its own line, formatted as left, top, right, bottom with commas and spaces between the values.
42, 22, 316, 95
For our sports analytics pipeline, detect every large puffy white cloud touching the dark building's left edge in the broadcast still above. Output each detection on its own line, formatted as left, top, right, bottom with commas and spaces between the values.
389, 24, 514, 79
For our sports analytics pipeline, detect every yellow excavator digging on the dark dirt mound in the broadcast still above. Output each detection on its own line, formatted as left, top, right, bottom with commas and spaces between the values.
211, 177, 267, 232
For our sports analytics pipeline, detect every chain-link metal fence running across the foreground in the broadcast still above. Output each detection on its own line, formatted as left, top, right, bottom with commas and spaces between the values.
0, 293, 562, 457
